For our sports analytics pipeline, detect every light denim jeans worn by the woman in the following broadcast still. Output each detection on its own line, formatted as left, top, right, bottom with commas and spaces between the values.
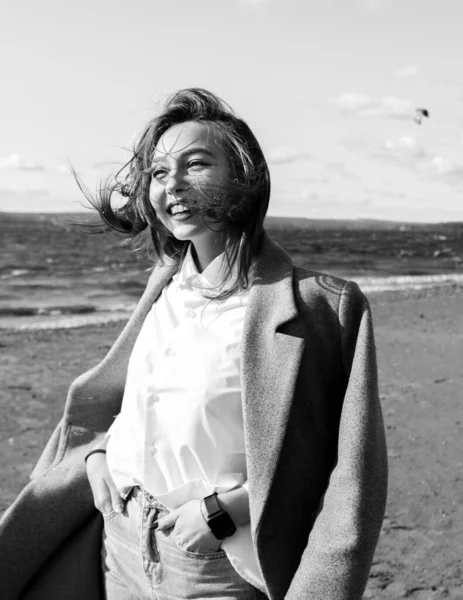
102, 488, 267, 600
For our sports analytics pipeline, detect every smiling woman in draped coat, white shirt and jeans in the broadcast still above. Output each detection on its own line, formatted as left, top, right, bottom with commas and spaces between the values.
0, 89, 387, 600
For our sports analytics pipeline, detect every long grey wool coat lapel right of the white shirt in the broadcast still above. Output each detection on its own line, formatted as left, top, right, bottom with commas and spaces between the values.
241, 233, 305, 537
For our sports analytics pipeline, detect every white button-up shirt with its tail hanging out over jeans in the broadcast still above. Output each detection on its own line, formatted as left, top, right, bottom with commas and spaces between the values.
107, 250, 266, 593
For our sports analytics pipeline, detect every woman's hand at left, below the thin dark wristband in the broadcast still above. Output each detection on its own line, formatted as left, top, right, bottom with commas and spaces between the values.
87, 452, 124, 515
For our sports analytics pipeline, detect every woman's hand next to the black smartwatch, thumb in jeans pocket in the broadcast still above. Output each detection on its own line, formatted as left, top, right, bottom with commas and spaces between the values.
156, 499, 222, 554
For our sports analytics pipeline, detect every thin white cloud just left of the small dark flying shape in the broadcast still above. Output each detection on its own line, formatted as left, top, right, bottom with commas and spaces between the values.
329, 93, 416, 119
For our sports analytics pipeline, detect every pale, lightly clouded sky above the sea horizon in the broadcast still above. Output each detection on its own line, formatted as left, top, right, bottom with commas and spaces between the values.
0, 0, 463, 222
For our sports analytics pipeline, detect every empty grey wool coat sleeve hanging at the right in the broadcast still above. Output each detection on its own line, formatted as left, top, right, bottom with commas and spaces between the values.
285, 282, 387, 600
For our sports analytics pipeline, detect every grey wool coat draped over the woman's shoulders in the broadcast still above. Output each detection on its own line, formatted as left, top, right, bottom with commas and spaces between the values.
0, 232, 387, 600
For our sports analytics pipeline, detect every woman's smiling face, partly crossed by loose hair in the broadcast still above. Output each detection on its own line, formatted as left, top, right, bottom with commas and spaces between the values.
150, 121, 230, 250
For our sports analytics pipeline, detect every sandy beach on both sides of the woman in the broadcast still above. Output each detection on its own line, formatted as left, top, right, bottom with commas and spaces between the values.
0, 285, 463, 600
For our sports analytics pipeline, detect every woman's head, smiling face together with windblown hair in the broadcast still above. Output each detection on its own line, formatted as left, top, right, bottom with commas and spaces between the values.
78, 88, 270, 297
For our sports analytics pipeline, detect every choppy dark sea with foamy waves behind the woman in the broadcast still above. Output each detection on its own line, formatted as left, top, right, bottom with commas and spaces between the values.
0, 213, 463, 331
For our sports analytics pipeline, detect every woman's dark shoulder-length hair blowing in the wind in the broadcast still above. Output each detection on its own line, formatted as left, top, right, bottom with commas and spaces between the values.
76, 88, 270, 299
